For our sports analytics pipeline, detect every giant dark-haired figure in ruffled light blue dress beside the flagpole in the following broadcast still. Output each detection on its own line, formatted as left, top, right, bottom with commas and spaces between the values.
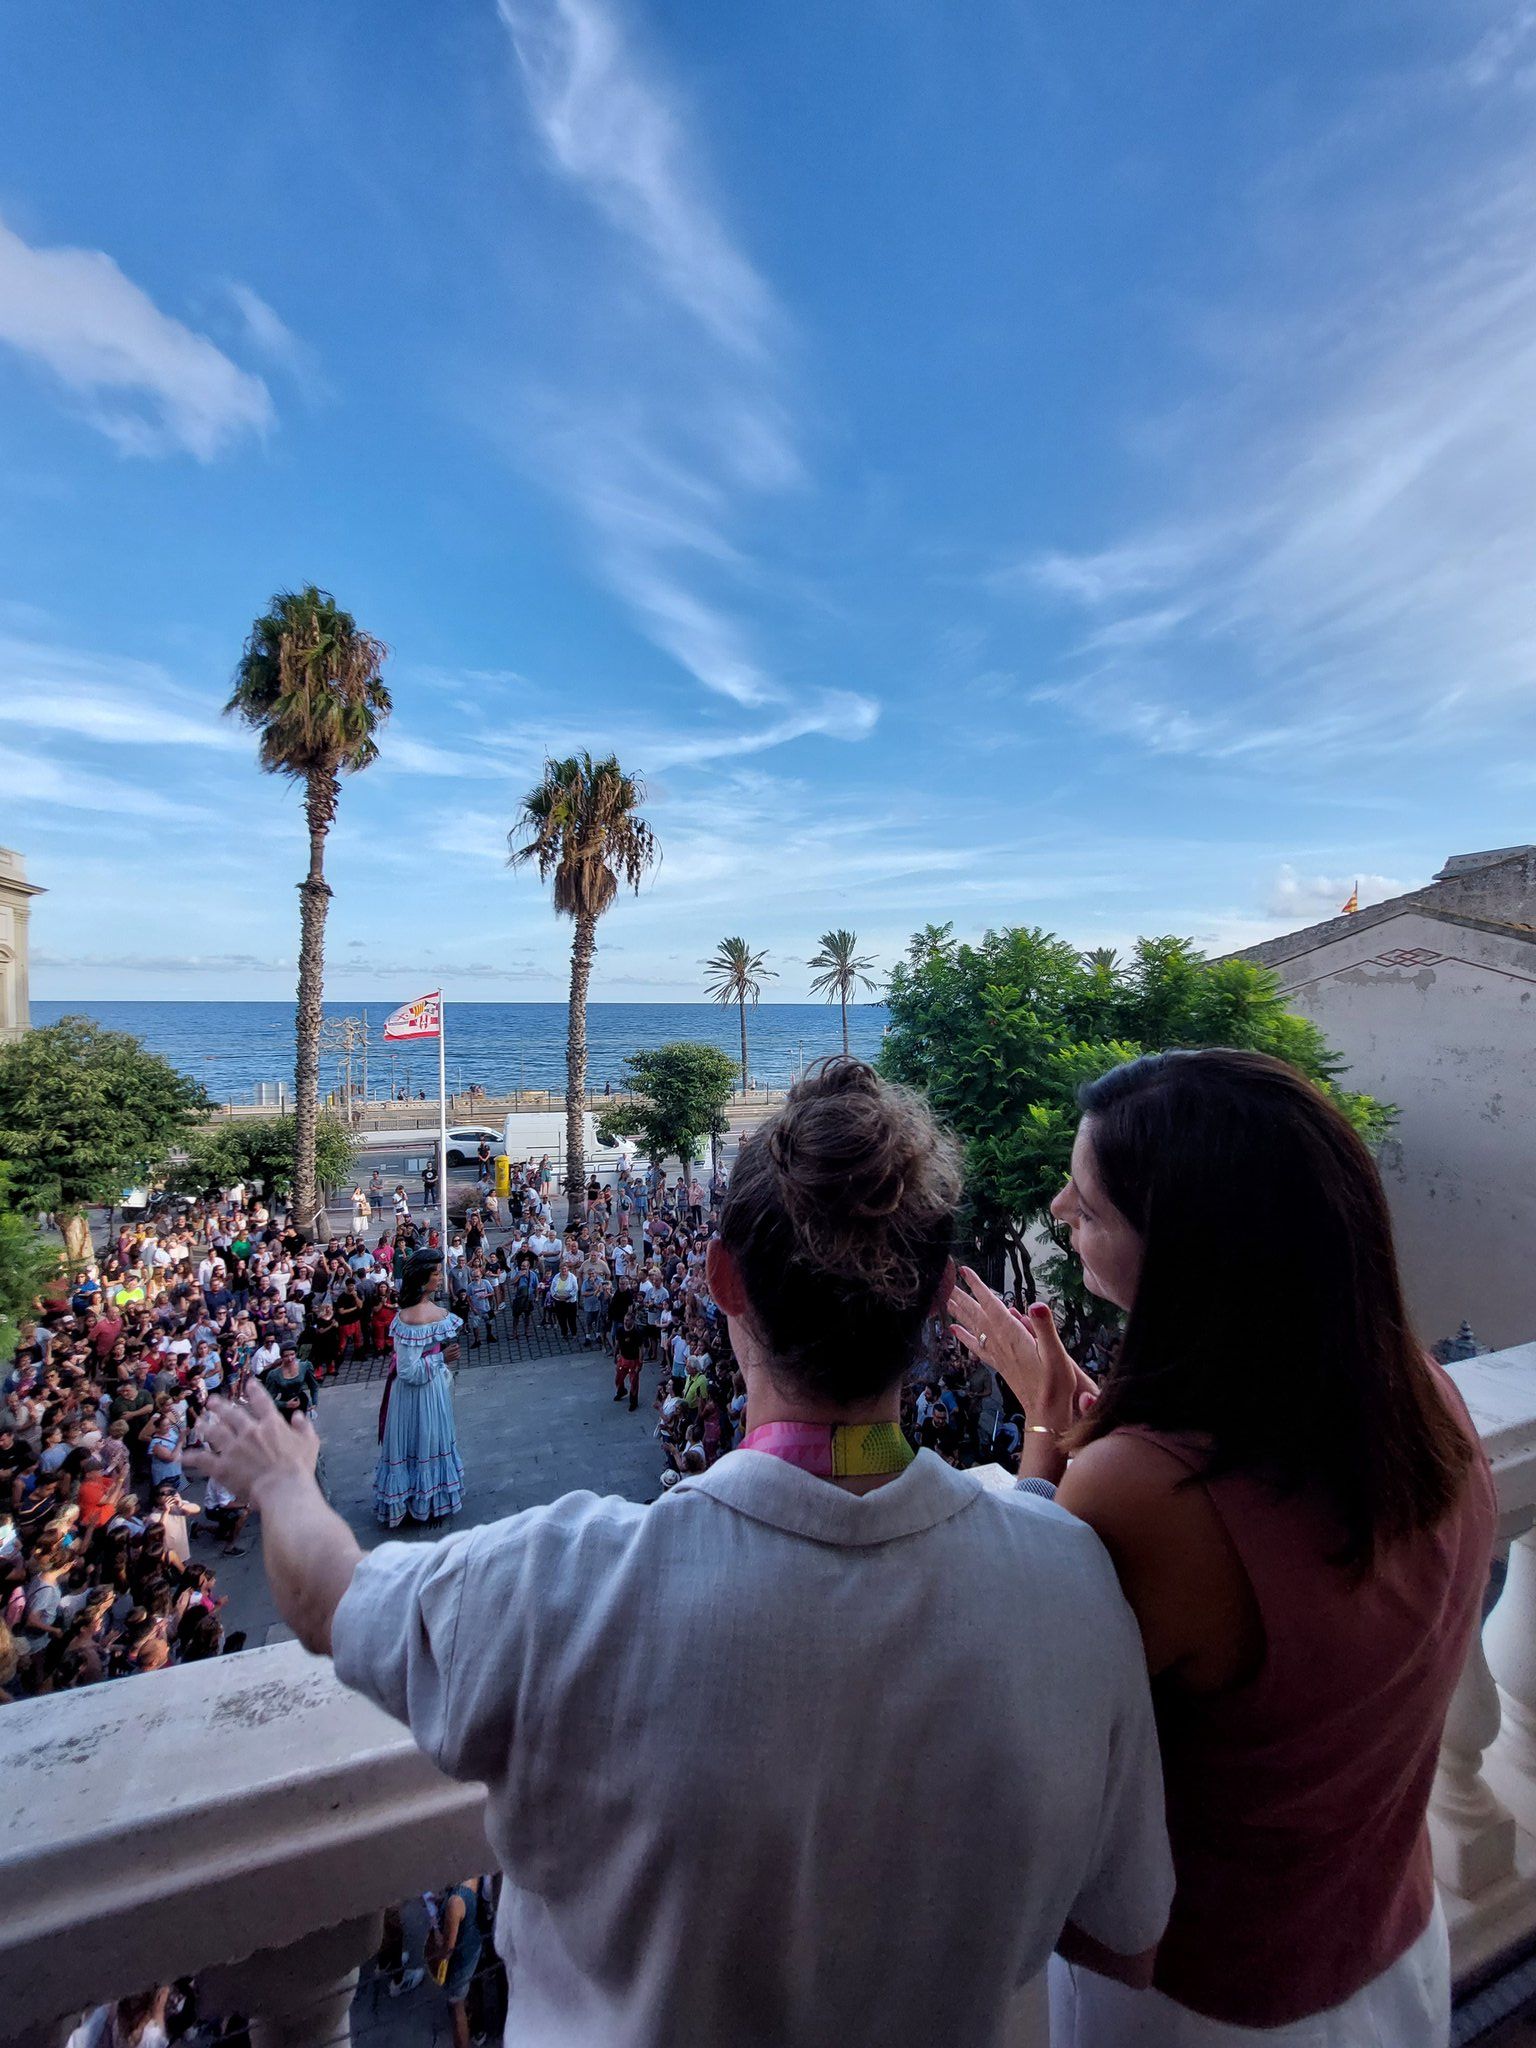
374, 1251, 465, 1530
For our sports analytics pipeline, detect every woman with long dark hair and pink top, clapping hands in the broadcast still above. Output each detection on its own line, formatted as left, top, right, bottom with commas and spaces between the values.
950, 1051, 1495, 2048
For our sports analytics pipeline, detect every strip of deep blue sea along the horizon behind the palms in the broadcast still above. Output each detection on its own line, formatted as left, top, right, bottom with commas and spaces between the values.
33, 1001, 887, 1102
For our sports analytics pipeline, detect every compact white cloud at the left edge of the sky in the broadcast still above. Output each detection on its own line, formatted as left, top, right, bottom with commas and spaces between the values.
0, 221, 274, 461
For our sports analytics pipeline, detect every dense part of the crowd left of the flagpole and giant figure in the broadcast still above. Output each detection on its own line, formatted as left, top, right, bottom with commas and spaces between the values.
0, 1186, 434, 1700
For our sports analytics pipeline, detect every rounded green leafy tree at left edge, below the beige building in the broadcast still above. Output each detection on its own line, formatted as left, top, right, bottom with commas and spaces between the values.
0, 1018, 207, 1264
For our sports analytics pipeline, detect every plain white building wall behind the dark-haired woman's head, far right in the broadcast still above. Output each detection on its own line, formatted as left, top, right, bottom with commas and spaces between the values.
1278, 911, 1536, 1346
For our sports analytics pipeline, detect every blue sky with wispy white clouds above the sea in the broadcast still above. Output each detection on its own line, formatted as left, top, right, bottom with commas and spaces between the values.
0, 0, 1536, 999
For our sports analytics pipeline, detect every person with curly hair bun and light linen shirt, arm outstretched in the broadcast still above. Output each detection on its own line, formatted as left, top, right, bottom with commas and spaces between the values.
195, 1059, 1171, 2048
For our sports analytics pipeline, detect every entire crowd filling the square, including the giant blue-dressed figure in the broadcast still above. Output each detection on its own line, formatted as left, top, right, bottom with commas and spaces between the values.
0, 1147, 1040, 1700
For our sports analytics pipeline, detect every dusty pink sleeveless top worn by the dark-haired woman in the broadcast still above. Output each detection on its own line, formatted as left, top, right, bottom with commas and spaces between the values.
1135, 1374, 1497, 2028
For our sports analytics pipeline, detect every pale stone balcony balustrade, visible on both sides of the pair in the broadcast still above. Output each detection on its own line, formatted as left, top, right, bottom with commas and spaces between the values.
0, 1343, 1536, 2048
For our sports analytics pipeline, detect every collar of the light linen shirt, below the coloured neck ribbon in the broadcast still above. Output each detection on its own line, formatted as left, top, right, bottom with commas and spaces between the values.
679, 1450, 983, 1548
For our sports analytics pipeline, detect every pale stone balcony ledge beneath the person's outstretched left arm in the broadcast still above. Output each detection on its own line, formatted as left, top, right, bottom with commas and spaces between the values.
0, 1642, 492, 2038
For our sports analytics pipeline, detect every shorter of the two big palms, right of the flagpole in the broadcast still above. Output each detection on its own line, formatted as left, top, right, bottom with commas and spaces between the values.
506, 754, 662, 1223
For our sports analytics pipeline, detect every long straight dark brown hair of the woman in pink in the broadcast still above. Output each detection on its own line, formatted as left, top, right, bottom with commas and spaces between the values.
1073, 1051, 1473, 1571
